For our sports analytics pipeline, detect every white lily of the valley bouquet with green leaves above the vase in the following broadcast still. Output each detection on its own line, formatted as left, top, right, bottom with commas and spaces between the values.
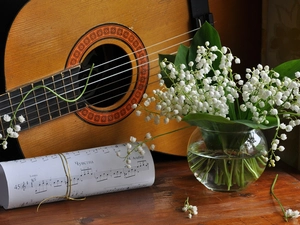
120, 23, 300, 171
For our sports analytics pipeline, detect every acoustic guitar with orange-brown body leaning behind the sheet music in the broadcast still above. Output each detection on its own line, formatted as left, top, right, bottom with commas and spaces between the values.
0, 0, 202, 160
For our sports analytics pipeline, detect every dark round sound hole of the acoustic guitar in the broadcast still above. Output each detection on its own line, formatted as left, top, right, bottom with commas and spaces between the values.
80, 44, 132, 108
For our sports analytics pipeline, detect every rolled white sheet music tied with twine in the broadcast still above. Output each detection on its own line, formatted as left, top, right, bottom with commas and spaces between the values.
0, 144, 155, 209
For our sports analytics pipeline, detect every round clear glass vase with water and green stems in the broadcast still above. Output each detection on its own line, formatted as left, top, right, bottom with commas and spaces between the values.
187, 124, 268, 191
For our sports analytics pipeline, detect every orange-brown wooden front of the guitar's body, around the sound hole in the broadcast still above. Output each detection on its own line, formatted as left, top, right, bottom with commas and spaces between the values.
0, 0, 193, 157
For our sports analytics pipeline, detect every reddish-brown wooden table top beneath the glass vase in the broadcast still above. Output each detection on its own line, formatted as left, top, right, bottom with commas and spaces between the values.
0, 156, 300, 225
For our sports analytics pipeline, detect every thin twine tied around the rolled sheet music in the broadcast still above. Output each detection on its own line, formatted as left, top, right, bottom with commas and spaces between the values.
36, 154, 86, 212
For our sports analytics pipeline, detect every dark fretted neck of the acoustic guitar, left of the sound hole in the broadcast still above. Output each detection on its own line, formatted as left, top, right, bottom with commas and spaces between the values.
0, 66, 85, 137
